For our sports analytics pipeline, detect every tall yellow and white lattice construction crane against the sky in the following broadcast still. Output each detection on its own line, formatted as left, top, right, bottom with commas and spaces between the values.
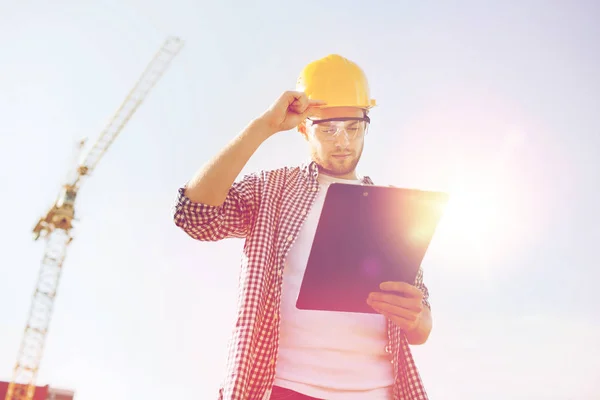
5, 37, 183, 400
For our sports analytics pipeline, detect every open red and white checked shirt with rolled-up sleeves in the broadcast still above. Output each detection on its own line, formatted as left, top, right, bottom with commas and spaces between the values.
173, 162, 430, 400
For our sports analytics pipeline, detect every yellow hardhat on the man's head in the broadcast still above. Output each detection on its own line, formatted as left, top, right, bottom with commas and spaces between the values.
296, 54, 376, 109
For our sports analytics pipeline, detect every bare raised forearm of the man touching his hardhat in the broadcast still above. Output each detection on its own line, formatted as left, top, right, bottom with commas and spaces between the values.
185, 119, 271, 206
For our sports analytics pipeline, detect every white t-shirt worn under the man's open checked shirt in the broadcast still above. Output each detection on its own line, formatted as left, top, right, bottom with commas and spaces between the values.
275, 174, 394, 400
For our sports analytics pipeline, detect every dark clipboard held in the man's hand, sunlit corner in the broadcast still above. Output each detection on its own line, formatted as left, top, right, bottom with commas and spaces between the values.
296, 183, 449, 314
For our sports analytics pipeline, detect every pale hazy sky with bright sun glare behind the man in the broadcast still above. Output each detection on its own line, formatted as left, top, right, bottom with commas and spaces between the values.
0, 0, 600, 400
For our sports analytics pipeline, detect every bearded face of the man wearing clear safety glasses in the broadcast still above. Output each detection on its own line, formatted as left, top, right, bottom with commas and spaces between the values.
300, 107, 368, 179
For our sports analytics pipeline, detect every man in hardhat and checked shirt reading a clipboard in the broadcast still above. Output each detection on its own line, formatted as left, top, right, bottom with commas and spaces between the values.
174, 55, 431, 400
